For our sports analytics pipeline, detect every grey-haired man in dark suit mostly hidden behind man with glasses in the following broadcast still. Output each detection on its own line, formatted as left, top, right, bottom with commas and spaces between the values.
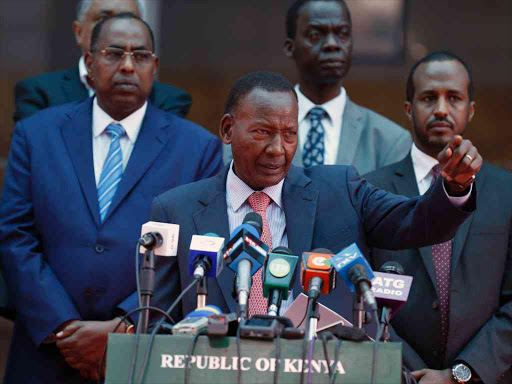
13, 0, 192, 122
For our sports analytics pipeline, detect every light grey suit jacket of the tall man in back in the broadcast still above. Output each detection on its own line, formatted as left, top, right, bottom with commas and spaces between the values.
223, 97, 412, 174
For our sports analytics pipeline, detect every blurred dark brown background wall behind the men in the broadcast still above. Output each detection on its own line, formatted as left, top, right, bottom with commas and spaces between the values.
0, 0, 512, 377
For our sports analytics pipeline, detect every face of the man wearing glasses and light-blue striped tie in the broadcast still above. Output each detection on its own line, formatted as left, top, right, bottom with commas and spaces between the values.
85, 19, 158, 121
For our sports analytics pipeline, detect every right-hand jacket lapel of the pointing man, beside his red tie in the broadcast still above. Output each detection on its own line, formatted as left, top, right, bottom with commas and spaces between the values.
283, 166, 319, 296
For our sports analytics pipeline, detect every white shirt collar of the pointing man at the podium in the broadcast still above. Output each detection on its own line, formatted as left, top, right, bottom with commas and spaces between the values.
226, 160, 284, 212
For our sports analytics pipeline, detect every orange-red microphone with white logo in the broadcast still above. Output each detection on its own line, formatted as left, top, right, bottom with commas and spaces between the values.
300, 248, 336, 300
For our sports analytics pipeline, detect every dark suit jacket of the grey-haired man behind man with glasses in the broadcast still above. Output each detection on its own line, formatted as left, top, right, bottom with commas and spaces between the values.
13, 66, 192, 122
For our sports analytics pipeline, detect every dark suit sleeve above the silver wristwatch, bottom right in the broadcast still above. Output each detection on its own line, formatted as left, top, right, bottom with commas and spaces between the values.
456, 225, 512, 384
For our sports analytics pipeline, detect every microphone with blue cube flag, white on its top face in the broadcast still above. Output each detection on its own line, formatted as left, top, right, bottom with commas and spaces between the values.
188, 233, 224, 278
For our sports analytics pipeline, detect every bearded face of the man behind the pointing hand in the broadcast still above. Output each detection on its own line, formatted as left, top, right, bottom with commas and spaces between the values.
405, 61, 475, 158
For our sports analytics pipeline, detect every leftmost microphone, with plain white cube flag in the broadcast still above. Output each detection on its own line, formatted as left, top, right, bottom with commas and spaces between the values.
138, 221, 180, 256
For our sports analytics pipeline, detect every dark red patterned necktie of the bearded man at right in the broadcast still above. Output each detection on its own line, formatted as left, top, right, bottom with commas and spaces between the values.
431, 164, 452, 358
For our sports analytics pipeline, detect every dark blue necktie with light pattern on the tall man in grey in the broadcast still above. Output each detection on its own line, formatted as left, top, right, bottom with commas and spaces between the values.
302, 107, 327, 168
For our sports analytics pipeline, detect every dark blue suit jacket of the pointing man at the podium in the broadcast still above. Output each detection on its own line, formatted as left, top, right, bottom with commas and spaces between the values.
152, 166, 474, 328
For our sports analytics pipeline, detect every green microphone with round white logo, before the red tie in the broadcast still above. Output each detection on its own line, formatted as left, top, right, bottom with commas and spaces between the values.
263, 247, 299, 316
